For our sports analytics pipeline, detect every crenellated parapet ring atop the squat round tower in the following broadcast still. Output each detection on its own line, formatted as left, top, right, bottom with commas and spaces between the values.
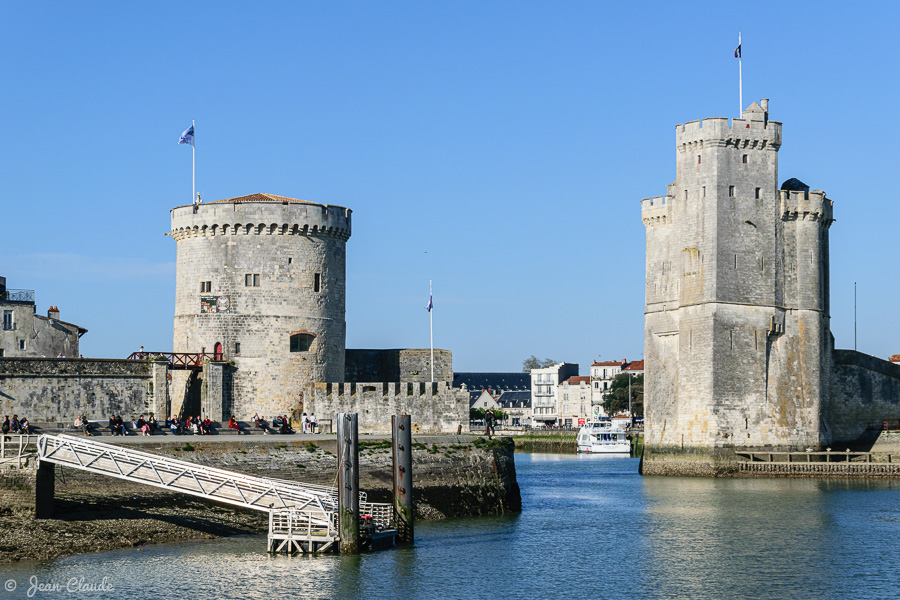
170, 200, 353, 242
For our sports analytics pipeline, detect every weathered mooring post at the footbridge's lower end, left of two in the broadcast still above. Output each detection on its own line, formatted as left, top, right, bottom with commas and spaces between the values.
337, 413, 359, 554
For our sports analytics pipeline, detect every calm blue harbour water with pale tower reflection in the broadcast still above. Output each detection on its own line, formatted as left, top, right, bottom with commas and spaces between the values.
0, 454, 900, 600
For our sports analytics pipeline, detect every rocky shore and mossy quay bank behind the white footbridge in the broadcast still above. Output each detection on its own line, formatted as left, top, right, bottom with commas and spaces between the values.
0, 438, 521, 564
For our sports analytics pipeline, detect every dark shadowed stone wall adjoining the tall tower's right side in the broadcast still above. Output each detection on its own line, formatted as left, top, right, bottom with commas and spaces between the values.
823, 350, 900, 443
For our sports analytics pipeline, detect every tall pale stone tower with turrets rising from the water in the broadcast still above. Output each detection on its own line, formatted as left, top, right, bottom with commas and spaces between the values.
641, 100, 833, 468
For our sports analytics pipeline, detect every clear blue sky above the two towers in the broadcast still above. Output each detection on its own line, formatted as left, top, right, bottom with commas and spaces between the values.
0, 1, 900, 372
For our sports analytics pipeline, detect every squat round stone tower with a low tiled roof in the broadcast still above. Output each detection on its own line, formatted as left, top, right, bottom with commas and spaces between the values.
171, 194, 351, 420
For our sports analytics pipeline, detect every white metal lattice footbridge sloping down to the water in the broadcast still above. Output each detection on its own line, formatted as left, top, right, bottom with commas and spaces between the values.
37, 434, 393, 553
